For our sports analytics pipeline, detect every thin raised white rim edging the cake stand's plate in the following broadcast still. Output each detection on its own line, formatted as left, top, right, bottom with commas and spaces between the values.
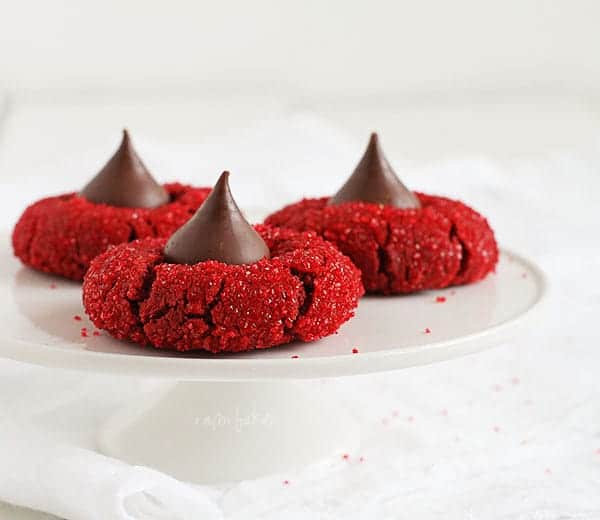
0, 247, 550, 381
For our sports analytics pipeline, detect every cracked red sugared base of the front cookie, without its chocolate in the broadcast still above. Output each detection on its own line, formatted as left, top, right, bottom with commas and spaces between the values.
83, 226, 364, 352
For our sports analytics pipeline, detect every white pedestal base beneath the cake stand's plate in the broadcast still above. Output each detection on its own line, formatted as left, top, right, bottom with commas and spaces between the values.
99, 381, 359, 483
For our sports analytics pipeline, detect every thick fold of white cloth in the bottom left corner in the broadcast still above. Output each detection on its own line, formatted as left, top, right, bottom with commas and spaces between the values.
0, 423, 221, 520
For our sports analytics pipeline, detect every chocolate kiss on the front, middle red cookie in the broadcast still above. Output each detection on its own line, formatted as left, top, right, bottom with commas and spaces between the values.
164, 172, 270, 264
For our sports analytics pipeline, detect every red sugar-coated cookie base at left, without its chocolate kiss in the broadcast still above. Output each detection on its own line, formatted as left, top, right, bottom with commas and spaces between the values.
12, 183, 210, 280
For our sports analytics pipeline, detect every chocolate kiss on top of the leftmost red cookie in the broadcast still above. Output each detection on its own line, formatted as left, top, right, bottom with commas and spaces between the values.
80, 130, 169, 208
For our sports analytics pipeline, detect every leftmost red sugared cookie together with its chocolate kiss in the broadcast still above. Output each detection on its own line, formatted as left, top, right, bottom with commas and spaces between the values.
12, 131, 210, 280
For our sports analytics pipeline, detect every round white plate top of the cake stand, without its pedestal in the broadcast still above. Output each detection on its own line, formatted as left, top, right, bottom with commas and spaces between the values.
0, 237, 547, 381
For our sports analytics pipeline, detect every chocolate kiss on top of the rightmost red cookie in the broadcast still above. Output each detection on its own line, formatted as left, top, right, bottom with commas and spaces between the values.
328, 133, 421, 208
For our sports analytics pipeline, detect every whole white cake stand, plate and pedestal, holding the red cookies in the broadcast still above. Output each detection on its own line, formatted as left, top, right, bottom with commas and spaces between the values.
0, 238, 547, 483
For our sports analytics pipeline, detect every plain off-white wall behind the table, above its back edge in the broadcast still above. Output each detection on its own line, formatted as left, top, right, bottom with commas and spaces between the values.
0, 0, 600, 97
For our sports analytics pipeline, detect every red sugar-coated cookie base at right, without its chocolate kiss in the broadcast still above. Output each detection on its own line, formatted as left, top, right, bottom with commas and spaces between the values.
265, 193, 498, 294
